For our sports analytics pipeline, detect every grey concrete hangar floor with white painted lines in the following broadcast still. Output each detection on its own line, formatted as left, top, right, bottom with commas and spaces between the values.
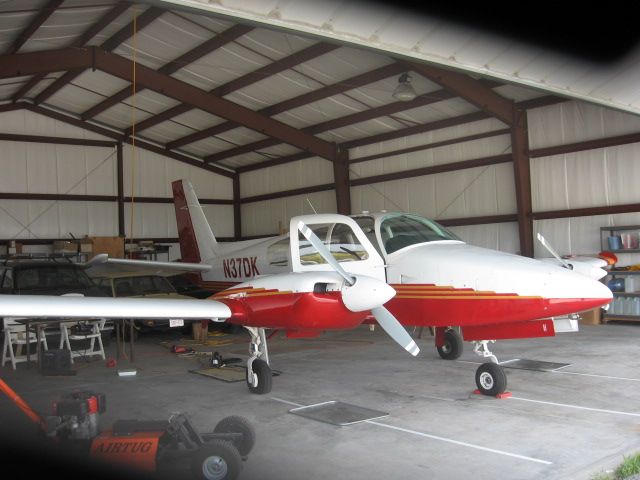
0, 324, 640, 480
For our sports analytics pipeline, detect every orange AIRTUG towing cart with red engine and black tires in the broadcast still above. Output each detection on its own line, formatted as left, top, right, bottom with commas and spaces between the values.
0, 379, 255, 480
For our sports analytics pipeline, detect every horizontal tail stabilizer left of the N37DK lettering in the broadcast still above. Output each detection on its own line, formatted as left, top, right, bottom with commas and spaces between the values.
84, 253, 211, 278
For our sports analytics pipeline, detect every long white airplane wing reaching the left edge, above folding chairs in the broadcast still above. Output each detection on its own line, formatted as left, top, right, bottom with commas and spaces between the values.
0, 295, 231, 321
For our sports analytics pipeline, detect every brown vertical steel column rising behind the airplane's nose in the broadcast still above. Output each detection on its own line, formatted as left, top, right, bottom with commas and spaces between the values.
511, 108, 533, 257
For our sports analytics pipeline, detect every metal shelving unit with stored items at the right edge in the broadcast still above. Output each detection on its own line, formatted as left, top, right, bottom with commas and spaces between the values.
600, 225, 640, 323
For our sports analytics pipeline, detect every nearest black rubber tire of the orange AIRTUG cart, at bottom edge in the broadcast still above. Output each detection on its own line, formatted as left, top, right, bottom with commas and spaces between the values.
191, 440, 242, 480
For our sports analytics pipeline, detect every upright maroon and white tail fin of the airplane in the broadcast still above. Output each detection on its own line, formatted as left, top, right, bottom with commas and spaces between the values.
171, 180, 218, 263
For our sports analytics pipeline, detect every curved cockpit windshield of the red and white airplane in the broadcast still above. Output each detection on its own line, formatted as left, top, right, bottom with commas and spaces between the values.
380, 214, 460, 254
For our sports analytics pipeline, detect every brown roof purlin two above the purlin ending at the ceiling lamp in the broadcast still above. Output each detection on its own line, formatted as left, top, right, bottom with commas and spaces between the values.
80, 25, 253, 120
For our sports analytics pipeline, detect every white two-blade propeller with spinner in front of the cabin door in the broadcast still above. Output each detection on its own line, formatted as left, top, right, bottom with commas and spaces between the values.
298, 221, 420, 357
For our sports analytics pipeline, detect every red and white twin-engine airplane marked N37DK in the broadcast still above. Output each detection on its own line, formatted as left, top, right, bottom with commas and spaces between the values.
0, 180, 612, 395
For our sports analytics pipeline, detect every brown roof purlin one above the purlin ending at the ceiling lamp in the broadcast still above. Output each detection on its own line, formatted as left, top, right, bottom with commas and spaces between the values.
125, 42, 340, 135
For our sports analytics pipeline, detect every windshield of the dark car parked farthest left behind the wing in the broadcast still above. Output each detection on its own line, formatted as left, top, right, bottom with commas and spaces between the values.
15, 265, 93, 290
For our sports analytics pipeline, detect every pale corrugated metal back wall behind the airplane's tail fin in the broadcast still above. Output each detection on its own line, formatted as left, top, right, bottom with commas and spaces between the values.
0, 110, 233, 255
